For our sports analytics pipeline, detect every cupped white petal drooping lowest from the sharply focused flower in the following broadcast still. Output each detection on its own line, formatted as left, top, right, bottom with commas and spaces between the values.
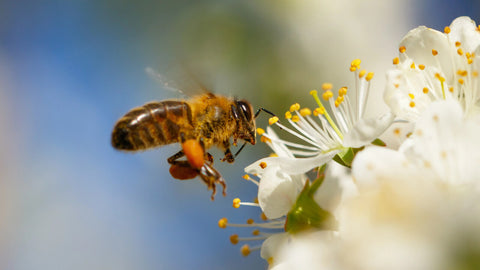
258, 166, 300, 219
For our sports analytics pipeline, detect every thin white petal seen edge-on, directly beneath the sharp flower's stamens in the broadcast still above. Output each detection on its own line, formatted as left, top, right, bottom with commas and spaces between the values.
245, 150, 339, 175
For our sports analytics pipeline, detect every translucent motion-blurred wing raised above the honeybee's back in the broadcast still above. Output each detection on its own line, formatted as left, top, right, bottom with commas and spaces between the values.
145, 67, 211, 98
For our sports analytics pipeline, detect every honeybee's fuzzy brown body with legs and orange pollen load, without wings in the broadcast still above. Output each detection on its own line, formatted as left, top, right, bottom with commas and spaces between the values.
112, 93, 262, 200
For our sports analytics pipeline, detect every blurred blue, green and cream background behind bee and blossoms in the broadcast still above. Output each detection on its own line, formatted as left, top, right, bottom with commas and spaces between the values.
0, 0, 480, 269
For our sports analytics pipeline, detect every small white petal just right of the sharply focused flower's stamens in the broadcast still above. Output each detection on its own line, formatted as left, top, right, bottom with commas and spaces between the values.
343, 112, 395, 148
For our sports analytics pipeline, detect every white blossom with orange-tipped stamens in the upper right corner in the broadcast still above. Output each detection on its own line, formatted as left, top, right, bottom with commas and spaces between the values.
384, 17, 480, 121
